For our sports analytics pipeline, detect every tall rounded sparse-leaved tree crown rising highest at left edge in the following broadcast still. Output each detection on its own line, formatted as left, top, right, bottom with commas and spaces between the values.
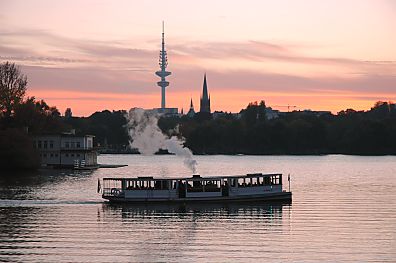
0, 61, 27, 117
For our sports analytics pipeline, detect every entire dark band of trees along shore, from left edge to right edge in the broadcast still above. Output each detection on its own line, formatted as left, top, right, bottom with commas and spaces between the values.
0, 62, 396, 169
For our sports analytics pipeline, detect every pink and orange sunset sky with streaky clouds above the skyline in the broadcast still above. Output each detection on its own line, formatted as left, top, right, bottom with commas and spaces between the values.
0, 0, 396, 116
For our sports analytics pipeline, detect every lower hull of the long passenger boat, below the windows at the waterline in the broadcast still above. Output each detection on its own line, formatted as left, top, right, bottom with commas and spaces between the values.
102, 192, 292, 203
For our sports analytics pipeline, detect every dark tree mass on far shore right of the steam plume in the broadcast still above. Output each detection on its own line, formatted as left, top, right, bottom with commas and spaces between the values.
180, 102, 396, 155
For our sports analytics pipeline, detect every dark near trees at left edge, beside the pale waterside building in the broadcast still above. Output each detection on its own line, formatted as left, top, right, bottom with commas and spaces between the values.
0, 62, 65, 170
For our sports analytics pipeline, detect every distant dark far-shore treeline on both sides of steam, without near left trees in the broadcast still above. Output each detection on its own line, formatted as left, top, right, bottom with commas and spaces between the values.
63, 102, 396, 155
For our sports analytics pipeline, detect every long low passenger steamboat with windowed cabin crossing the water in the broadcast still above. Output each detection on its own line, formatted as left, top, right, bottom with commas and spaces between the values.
98, 173, 292, 203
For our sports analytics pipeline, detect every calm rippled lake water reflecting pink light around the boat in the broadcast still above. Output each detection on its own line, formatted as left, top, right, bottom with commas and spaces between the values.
0, 155, 396, 262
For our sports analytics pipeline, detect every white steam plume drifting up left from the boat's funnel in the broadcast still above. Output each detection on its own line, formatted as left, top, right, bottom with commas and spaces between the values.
126, 108, 197, 173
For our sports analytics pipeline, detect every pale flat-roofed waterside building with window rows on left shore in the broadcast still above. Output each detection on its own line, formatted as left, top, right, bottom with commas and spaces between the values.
33, 133, 97, 167
